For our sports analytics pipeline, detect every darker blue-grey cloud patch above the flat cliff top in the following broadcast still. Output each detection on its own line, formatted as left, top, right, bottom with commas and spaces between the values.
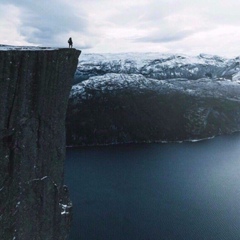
3, 0, 88, 45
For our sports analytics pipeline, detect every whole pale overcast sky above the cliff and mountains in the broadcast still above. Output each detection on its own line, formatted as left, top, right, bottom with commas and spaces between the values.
0, 0, 240, 57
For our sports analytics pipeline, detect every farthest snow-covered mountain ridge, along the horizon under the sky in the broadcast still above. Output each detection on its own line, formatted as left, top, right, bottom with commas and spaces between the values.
75, 53, 240, 83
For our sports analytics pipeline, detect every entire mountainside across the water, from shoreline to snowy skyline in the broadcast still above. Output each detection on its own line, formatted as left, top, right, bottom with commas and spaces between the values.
66, 53, 240, 145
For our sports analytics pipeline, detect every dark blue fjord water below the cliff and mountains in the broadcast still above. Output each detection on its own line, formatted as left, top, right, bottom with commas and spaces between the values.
65, 134, 240, 240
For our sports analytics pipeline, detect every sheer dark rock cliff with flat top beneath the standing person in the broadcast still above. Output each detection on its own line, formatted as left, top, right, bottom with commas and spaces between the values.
0, 46, 80, 240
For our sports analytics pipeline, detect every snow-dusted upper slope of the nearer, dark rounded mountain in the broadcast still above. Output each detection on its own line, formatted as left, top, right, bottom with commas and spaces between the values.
70, 73, 240, 101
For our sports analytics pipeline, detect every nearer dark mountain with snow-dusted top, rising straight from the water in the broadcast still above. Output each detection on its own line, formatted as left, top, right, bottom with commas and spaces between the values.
67, 73, 240, 145
